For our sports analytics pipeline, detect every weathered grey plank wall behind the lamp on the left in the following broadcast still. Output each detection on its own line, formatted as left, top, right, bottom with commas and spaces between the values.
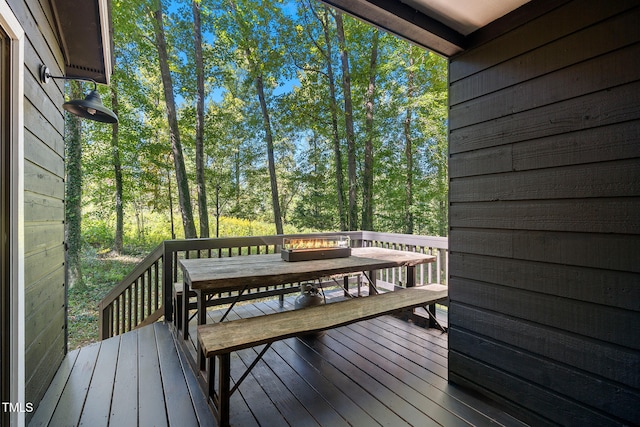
9, 0, 66, 412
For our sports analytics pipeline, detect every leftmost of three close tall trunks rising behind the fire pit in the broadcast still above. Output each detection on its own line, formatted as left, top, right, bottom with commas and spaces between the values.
321, 6, 347, 231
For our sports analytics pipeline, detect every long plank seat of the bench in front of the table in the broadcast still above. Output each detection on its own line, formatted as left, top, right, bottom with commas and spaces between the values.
198, 285, 448, 358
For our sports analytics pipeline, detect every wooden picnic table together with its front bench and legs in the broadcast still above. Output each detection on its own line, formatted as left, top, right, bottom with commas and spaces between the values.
180, 247, 440, 427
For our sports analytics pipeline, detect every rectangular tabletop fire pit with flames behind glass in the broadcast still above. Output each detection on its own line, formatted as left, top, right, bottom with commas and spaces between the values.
281, 236, 351, 262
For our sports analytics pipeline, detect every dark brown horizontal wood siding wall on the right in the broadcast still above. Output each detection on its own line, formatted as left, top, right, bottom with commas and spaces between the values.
449, 0, 640, 426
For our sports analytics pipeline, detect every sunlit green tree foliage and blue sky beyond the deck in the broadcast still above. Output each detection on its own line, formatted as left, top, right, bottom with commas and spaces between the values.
82, 0, 448, 250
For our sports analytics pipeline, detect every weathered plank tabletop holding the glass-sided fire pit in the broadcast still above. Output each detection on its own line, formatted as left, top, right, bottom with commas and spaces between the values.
179, 248, 436, 291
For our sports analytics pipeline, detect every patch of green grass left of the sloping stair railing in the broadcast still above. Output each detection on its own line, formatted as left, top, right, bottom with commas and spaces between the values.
68, 248, 142, 350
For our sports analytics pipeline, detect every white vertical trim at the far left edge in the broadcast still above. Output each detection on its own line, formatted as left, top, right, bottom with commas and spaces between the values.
0, 0, 26, 427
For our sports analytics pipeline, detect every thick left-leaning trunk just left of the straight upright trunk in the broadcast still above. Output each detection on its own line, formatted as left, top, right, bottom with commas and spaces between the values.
153, 0, 196, 239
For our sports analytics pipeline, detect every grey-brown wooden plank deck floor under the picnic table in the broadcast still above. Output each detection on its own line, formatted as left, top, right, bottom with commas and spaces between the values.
30, 298, 524, 427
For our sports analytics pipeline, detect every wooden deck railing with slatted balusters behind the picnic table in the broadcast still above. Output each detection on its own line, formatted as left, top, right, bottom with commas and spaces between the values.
99, 231, 448, 339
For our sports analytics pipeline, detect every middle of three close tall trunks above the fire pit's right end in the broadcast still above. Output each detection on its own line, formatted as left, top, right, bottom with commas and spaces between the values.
335, 12, 358, 230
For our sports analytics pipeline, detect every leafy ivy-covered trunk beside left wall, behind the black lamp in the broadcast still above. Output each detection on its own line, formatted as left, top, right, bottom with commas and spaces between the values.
65, 81, 84, 287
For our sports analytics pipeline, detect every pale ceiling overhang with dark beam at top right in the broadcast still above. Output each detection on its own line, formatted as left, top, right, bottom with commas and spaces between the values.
323, 0, 536, 57
